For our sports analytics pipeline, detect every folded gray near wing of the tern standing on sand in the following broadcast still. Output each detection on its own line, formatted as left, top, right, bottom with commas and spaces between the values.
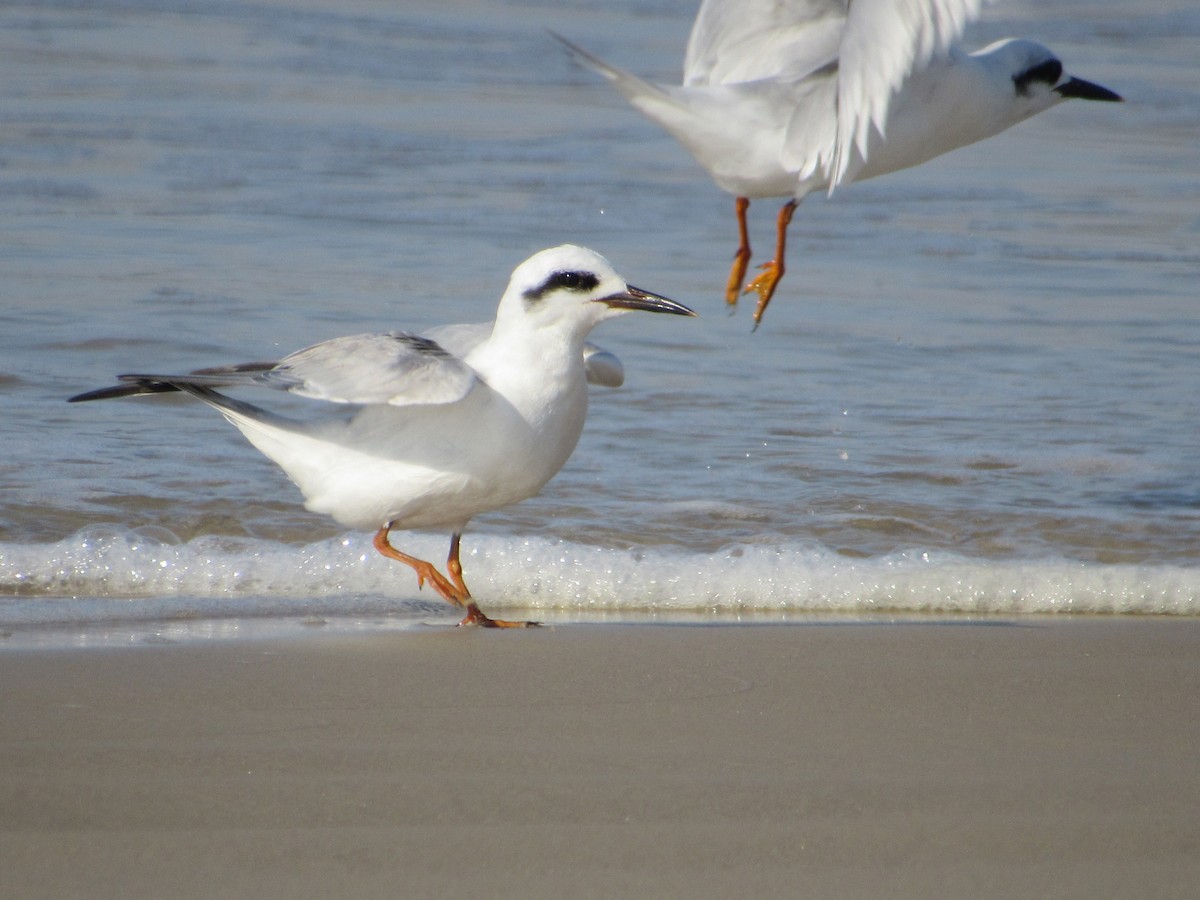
71, 331, 478, 406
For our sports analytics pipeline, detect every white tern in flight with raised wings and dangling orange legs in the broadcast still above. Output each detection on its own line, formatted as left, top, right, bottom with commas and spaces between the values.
552, 0, 1121, 328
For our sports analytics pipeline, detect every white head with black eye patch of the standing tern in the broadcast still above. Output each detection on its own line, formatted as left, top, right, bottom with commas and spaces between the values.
496, 244, 696, 337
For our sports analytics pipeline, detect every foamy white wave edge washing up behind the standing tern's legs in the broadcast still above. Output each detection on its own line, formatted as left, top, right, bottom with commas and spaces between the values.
0, 526, 1200, 628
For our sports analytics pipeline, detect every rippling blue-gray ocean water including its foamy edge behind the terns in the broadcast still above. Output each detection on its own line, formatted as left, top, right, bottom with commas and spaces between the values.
0, 0, 1200, 643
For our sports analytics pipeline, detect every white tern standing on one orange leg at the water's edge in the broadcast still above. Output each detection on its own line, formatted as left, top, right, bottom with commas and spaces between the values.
70, 245, 696, 628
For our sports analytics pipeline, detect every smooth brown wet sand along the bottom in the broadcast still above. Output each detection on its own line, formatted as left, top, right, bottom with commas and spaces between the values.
0, 617, 1200, 898
